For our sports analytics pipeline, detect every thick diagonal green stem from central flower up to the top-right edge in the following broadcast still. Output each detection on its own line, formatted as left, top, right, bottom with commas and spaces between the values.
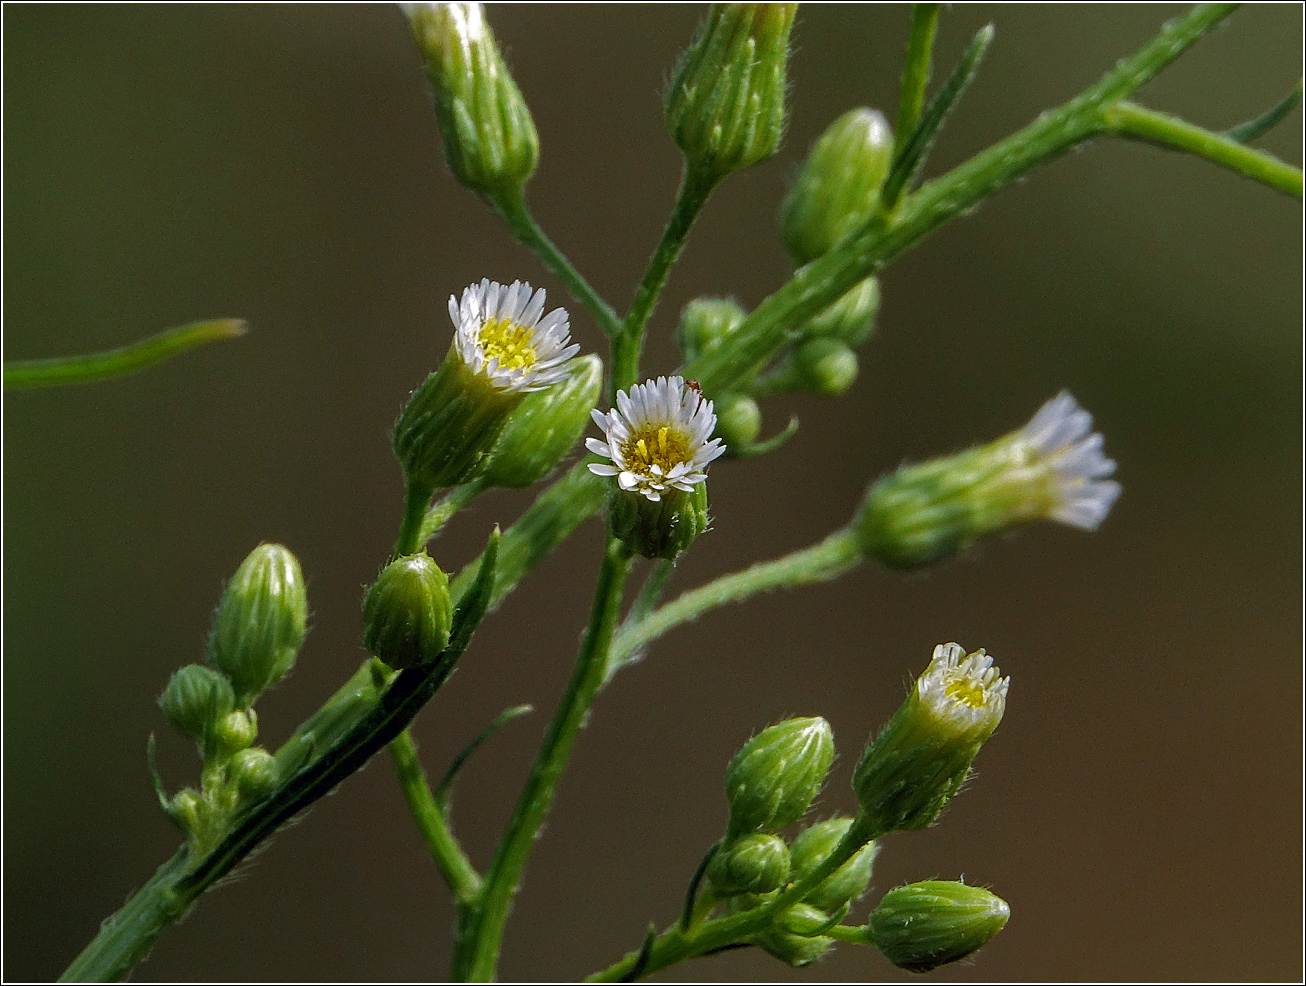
684, 4, 1235, 394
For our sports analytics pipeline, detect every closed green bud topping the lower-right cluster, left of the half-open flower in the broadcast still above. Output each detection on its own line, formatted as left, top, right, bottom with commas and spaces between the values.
726, 717, 835, 837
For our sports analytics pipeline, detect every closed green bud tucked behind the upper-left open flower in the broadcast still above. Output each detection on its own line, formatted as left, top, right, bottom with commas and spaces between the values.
481, 354, 603, 490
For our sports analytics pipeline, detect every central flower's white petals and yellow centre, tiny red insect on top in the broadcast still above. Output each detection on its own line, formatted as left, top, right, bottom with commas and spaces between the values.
585, 376, 726, 501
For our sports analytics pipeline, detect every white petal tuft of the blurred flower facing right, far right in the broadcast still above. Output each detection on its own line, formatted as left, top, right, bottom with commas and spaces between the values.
1015, 390, 1121, 530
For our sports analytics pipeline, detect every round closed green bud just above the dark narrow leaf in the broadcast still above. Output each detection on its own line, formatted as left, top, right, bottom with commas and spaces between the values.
363, 551, 453, 667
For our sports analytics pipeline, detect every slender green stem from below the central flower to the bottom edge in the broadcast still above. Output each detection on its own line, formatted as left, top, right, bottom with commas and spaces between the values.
453, 537, 631, 982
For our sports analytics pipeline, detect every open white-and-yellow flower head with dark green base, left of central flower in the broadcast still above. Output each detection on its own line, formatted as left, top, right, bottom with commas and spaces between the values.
392, 278, 580, 491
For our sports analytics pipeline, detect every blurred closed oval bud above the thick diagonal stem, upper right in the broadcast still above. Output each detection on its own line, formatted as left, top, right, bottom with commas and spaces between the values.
780, 107, 893, 266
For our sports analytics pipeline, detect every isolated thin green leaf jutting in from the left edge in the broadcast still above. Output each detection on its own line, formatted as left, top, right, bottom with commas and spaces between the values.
4, 319, 248, 390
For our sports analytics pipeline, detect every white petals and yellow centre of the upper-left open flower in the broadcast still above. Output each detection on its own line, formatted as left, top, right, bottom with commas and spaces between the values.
449, 278, 580, 393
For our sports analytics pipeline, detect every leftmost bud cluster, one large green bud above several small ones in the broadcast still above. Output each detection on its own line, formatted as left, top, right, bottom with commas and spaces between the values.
159, 545, 308, 853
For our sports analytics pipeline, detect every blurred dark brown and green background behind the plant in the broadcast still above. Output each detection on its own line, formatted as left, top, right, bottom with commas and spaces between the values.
4, 4, 1302, 981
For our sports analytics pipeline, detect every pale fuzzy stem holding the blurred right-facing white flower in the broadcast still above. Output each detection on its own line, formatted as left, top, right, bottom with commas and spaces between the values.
609, 530, 862, 675
